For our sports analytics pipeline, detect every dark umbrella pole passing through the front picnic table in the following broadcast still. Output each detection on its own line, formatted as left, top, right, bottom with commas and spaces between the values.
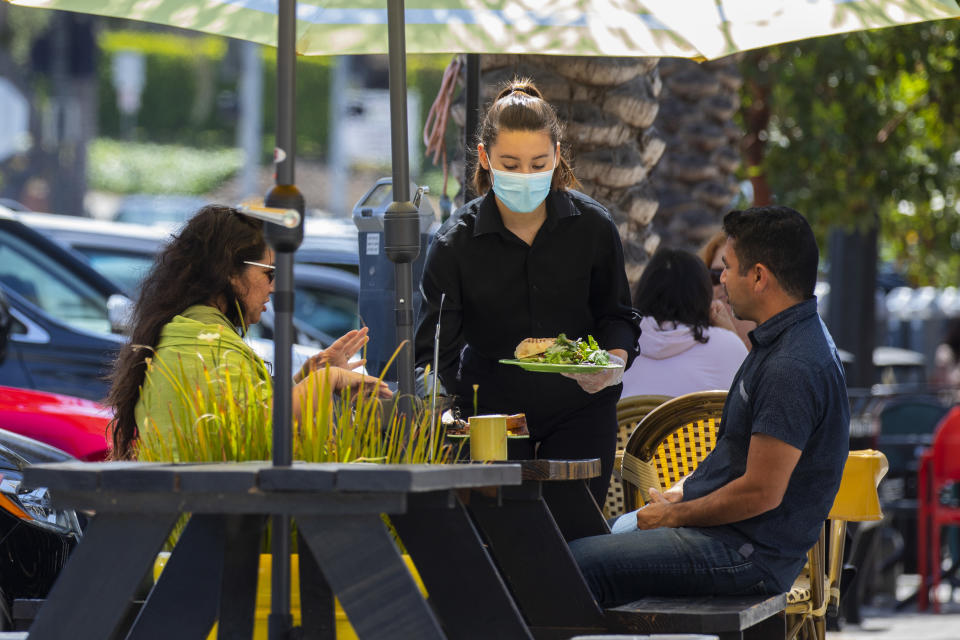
264, 0, 305, 640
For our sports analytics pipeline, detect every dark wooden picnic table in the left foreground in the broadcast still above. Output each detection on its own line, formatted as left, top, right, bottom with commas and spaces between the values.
24, 462, 530, 640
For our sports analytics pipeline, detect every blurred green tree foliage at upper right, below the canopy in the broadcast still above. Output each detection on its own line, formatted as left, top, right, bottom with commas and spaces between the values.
741, 20, 960, 286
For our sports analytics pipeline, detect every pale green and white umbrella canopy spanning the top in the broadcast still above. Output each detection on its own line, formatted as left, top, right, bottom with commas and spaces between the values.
8, 0, 960, 59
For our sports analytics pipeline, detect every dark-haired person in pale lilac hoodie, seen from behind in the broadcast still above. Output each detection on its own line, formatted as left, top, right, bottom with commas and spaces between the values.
621, 248, 747, 398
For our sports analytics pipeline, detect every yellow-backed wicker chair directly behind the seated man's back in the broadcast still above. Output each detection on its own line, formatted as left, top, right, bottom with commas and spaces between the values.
786, 449, 888, 640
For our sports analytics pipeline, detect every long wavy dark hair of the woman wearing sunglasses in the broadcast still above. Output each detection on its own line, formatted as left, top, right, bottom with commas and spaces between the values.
105, 205, 266, 460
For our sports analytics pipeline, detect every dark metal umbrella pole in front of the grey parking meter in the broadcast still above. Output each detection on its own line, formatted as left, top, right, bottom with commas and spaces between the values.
383, 0, 420, 417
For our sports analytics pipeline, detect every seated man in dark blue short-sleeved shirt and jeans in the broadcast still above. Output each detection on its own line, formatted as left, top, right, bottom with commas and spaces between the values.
570, 206, 850, 607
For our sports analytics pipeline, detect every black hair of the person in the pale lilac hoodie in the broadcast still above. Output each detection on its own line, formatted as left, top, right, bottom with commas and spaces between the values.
633, 248, 713, 343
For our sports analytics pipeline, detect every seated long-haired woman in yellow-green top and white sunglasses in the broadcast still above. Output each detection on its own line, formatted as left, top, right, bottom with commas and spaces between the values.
106, 205, 391, 459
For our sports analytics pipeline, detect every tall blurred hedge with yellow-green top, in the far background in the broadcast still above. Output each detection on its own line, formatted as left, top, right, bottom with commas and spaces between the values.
98, 31, 450, 164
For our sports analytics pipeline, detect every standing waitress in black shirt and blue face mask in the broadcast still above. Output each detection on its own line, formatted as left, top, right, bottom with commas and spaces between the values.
416, 80, 640, 503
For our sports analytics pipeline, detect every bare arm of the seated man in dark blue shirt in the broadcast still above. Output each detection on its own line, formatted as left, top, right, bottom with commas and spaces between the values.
637, 433, 801, 529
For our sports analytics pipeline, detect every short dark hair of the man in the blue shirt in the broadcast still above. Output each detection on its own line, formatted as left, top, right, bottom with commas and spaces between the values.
723, 206, 820, 300
